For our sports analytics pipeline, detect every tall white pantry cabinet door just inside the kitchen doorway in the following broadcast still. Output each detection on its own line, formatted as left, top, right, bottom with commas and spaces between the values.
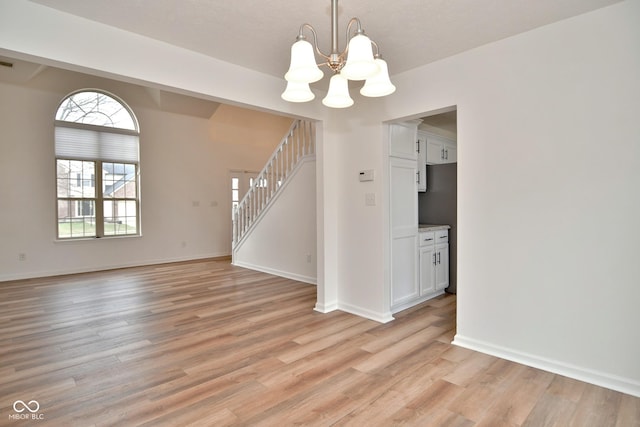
389, 157, 419, 306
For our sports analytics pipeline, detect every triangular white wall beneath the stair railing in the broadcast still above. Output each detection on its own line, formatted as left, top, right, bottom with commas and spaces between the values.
233, 159, 317, 284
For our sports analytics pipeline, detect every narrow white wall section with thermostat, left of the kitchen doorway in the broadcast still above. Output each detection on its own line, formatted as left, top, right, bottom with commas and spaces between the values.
327, 112, 391, 322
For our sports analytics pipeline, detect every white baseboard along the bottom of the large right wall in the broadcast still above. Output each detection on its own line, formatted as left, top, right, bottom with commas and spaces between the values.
452, 334, 640, 397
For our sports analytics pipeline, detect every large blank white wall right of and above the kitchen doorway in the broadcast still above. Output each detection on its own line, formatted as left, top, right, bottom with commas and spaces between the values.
380, 0, 640, 395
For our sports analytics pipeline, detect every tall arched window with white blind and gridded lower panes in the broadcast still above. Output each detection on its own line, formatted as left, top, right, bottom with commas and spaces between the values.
55, 89, 140, 239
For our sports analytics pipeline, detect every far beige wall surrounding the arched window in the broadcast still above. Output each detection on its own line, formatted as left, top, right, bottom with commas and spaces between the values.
0, 69, 291, 281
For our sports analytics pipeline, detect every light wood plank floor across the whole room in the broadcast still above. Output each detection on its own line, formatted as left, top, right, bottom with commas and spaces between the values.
0, 260, 640, 427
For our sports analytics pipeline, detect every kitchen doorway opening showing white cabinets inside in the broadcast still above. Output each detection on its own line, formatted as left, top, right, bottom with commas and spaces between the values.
388, 106, 458, 320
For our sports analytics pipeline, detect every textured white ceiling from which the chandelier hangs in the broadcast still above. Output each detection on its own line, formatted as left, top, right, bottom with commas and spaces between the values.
32, 0, 621, 76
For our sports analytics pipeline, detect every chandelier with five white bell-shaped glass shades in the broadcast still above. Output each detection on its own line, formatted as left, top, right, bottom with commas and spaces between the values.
282, 0, 396, 108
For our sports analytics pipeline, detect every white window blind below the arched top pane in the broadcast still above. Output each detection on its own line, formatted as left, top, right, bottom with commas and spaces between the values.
55, 126, 139, 163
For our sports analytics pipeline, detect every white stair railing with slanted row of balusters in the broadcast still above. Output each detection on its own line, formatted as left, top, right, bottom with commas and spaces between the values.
232, 120, 316, 248
